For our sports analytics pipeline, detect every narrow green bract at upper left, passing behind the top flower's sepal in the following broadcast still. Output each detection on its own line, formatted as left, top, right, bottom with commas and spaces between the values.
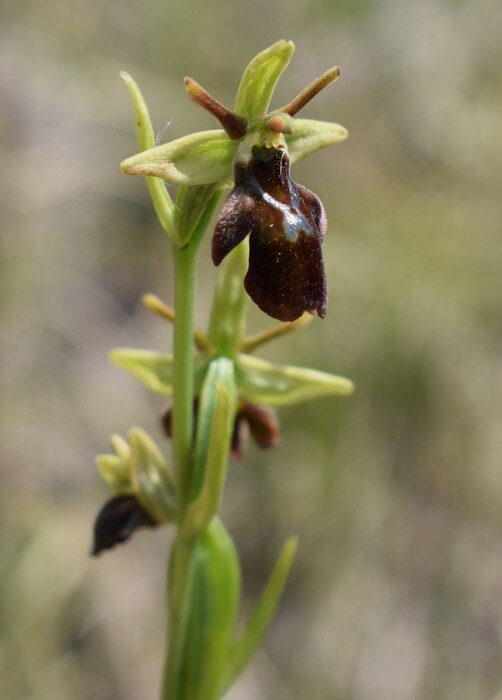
120, 71, 178, 243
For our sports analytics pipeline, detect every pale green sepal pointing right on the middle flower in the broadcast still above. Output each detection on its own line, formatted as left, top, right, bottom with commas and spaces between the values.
237, 354, 354, 406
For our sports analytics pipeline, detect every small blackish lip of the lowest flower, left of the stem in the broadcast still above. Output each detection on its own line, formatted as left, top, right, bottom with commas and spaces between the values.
92, 496, 157, 557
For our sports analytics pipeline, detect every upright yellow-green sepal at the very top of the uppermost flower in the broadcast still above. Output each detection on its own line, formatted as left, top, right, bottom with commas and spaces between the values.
234, 39, 295, 127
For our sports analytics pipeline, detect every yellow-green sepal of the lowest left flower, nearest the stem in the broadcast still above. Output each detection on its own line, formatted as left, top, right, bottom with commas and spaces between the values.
127, 428, 176, 523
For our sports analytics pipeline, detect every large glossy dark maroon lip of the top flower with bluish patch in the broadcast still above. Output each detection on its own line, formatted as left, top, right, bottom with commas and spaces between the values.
212, 145, 327, 321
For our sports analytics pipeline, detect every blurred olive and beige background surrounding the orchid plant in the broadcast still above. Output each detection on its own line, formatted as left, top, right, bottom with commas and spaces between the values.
0, 0, 502, 700
